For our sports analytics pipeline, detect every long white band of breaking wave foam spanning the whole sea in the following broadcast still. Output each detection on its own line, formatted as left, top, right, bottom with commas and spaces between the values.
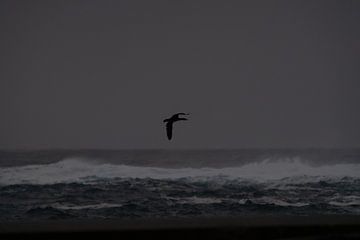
0, 158, 360, 185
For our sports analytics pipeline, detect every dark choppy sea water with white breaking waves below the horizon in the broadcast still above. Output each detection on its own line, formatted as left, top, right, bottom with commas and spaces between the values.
0, 149, 360, 222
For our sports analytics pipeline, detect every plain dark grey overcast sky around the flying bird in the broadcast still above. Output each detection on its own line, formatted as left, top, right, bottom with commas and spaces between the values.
0, 0, 360, 149
